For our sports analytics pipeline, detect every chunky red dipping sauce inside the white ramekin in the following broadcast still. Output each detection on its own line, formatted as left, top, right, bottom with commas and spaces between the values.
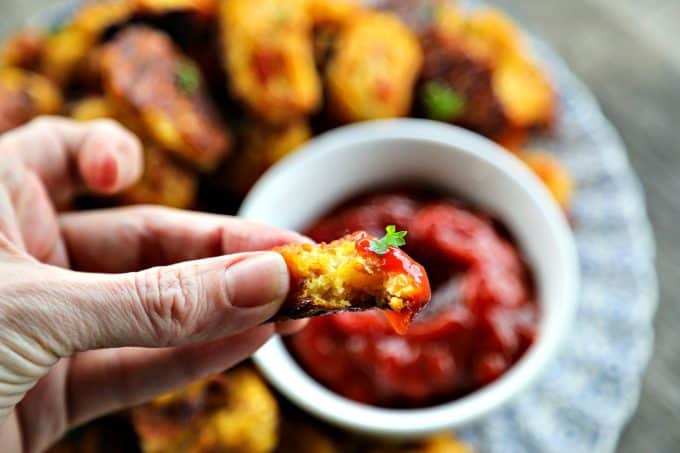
289, 191, 539, 407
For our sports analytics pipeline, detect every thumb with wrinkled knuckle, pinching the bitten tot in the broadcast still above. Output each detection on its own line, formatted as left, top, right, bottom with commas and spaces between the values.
19, 252, 289, 357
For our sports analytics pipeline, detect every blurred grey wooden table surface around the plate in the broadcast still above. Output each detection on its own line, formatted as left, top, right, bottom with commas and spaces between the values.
0, 0, 680, 453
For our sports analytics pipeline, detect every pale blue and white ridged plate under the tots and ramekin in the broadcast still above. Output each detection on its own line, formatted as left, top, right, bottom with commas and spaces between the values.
30, 0, 658, 453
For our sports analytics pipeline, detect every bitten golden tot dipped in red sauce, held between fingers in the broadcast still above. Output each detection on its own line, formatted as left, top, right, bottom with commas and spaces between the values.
274, 232, 430, 333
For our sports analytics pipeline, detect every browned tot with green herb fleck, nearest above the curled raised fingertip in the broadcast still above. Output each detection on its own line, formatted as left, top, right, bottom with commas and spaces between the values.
100, 26, 232, 171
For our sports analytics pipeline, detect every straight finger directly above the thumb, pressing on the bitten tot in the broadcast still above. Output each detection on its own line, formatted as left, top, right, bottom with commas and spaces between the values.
60, 206, 309, 273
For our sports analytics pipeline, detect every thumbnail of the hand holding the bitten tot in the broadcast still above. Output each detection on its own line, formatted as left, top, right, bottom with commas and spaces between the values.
226, 252, 289, 308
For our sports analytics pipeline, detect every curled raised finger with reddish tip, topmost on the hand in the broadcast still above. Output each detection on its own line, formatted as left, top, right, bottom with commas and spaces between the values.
0, 117, 142, 201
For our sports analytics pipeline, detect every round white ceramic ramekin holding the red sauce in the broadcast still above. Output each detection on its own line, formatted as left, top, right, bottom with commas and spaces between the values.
241, 119, 579, 437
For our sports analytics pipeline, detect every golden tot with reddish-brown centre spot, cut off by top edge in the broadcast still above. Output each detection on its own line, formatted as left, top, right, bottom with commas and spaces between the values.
220, 0, 321, 124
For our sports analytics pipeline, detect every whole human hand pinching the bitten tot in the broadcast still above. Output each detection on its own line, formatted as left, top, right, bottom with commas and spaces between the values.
0, 118, 303, 452
